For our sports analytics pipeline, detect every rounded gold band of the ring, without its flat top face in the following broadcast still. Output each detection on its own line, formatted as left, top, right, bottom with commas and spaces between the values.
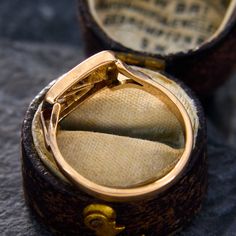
40, 51, 193, 201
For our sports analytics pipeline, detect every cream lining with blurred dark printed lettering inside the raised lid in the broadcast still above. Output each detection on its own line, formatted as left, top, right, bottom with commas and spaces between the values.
87, 0, 236, 55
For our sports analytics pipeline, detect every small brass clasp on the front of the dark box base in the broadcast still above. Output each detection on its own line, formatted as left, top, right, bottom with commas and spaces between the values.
83, 204, 125, 236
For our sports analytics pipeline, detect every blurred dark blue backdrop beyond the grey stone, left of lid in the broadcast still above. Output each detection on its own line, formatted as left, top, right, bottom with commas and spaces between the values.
0, 0, 80, 45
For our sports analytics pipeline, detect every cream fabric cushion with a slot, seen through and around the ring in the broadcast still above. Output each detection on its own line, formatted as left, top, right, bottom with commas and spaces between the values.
32, 66, 199, 188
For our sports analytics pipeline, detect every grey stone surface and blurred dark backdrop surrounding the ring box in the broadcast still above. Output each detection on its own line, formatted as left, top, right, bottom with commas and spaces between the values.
0, 0, 236, 236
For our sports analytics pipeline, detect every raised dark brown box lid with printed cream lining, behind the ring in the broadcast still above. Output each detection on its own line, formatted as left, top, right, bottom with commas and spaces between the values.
78, 0, 236, 95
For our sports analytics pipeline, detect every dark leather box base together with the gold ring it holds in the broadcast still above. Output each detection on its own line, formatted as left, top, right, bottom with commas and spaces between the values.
22, 51, 207, 236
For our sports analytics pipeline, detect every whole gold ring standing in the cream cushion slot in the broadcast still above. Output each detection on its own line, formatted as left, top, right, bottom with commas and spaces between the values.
41, 51, 193, 201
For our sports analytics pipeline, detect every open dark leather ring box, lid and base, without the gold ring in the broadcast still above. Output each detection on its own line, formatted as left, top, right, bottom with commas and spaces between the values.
22, 0, 235, 236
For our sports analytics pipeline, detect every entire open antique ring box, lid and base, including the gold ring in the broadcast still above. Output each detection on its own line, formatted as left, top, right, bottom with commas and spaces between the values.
22, 0, 236, 236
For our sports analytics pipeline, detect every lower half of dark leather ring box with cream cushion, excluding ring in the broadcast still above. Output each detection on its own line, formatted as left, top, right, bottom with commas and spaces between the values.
22, 68, 207, 236
